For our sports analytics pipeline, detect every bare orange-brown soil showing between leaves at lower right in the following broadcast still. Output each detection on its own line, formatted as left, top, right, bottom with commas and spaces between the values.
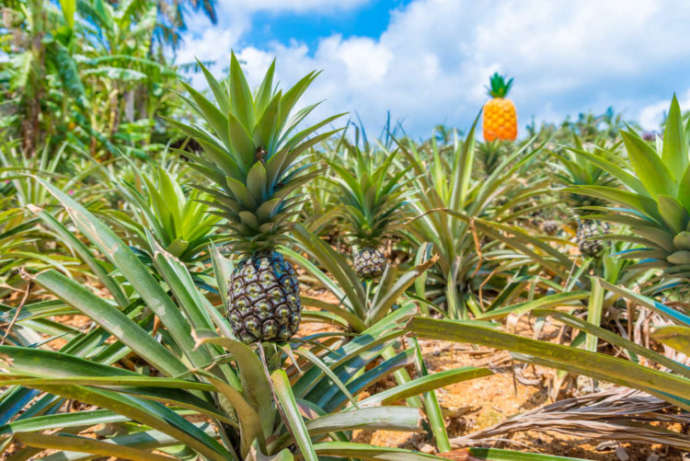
356, 334, 686, 461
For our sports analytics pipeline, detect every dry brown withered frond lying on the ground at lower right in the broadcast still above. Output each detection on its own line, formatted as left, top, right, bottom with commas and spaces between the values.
451, 387, 690, 450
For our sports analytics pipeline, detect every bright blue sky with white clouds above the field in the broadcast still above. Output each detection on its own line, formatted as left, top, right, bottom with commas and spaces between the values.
177, 0, 690, 136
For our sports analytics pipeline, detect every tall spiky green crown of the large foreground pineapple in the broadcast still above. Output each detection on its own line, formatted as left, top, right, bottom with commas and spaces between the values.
171, 53, 343, 252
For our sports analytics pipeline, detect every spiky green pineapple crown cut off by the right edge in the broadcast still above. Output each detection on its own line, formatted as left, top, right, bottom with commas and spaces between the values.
569, 95, 690, 286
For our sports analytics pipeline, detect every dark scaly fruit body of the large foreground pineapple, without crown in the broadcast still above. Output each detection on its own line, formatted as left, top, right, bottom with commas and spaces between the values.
228, 252, 302, 343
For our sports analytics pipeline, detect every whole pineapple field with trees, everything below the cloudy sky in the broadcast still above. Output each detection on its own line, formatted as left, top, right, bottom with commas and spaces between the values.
0, 0, 690, 461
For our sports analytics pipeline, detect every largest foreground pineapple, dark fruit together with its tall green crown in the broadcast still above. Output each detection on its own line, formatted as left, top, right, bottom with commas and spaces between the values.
175, 54, 340, 343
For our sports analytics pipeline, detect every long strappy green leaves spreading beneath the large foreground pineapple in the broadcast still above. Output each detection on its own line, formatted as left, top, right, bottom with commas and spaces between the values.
8, 179, 462, 461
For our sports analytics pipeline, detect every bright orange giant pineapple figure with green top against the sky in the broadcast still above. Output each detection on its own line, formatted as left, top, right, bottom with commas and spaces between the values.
482, 72, 517, 142
